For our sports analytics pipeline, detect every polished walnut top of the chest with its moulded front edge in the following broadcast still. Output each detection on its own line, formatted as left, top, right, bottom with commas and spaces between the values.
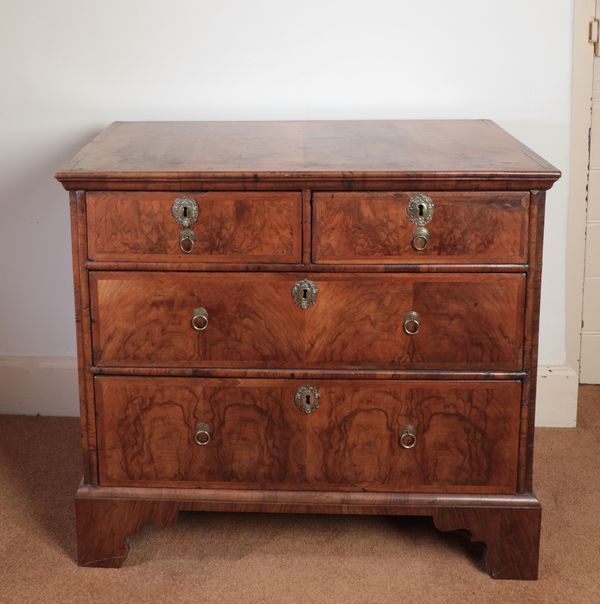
56, 120, 560, 190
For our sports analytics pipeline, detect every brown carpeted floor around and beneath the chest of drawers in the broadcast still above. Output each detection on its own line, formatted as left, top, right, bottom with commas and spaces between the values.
0, 386, 600, 604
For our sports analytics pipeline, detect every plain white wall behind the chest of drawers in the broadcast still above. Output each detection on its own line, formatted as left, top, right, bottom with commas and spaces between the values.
0, 0, 572, 414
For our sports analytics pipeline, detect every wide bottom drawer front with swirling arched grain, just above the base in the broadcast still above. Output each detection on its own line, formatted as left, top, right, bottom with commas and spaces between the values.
95, 377, 521, 493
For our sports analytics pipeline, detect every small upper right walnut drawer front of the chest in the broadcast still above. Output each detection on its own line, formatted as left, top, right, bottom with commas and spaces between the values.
313, 192, 529, 264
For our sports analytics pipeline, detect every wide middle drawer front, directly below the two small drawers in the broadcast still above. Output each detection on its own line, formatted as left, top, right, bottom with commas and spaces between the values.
90, 272, 525, 370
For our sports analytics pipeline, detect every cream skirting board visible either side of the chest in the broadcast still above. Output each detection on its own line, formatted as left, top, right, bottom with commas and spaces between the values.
0, 357, 578, 428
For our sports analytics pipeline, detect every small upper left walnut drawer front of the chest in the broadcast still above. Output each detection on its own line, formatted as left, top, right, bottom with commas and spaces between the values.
86, 192, 302, 263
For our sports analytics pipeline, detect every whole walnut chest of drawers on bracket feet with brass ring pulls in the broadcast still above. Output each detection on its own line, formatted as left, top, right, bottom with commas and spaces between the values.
57, 120, 560, 579
